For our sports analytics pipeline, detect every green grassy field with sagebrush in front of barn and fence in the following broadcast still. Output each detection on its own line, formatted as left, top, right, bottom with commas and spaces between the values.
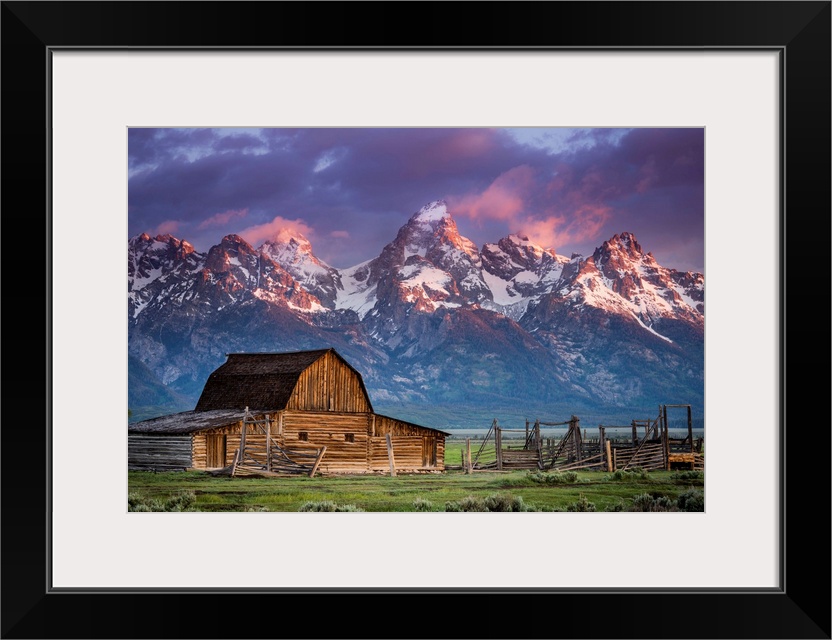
128, 441, 704, 512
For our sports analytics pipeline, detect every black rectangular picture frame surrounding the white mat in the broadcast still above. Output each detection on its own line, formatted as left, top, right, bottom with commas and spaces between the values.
0, 1, 832, 638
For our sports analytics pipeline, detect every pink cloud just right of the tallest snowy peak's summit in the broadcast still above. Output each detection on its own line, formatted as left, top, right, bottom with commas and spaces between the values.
448, 165, 534, 221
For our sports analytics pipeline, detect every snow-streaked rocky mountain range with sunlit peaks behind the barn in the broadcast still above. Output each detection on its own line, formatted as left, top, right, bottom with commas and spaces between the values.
128, 201, 705, 428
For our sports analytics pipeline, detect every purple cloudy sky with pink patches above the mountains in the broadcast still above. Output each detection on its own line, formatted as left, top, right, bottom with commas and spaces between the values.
128, 128, 705, 273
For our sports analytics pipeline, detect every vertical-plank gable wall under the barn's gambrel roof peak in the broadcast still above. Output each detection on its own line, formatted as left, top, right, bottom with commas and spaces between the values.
286, 353, 370, 413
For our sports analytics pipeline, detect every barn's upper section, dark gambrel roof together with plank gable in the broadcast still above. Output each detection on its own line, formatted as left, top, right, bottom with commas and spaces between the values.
195, 349, 373, 412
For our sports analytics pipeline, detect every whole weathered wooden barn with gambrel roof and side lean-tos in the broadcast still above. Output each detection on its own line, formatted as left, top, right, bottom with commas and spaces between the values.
128, 349, 448, 475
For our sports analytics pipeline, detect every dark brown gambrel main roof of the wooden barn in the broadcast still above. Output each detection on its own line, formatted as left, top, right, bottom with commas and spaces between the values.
196, 349, 372, 411
